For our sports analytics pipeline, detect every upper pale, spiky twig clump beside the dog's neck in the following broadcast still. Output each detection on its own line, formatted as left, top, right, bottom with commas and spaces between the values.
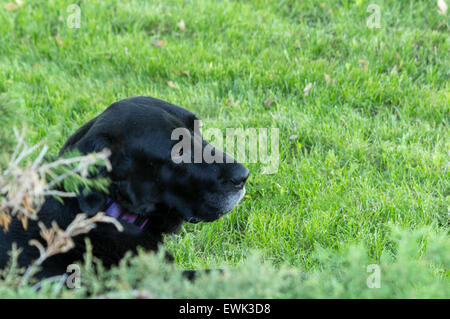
0, 129, 111, 231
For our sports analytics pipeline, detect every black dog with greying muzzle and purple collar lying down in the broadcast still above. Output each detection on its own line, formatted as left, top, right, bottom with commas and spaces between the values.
0, 97, 249, 277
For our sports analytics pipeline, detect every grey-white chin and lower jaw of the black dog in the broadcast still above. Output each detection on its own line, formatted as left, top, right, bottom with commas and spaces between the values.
185, 187, 245, 224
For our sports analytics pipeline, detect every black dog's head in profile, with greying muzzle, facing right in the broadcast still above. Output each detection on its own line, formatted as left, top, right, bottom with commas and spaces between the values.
60, 97, 249, 234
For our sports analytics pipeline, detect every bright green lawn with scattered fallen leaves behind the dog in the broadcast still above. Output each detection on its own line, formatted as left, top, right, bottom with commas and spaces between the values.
0, 0, 450, 297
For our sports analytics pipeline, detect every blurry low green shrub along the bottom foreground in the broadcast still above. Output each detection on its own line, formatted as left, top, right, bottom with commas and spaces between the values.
0, 228, 450, 298
